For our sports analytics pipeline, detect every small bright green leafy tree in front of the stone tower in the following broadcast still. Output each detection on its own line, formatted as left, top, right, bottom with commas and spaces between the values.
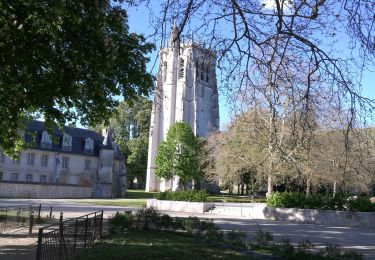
155, 122, 203, 187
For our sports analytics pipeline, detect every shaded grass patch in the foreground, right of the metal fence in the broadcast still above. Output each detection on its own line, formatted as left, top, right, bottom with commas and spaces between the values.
78, 230, 249, 260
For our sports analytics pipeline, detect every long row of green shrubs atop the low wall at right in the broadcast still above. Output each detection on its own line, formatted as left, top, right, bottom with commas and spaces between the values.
267, 192, 375, 212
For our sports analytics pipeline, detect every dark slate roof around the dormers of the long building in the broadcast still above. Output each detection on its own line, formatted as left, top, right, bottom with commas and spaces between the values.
25, 120, 108, 156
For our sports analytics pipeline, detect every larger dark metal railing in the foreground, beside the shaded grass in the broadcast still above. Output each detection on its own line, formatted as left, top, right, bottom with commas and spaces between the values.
36, 211, 103, 260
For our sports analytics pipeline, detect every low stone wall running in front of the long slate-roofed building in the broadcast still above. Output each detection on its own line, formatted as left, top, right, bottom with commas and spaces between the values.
0, 182, 93, 199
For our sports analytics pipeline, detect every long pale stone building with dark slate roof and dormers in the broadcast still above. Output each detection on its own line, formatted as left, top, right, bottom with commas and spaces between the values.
0, 121, 125, 198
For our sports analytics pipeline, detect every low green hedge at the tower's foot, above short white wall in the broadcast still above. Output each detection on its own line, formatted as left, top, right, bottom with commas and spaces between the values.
155, 190, 210, 202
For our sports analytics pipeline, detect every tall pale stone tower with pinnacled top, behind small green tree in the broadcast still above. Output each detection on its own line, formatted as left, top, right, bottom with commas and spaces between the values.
146, 26, 219, 191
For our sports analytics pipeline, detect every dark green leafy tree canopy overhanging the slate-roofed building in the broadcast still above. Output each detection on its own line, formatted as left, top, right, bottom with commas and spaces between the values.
0, 0, 154, 154
